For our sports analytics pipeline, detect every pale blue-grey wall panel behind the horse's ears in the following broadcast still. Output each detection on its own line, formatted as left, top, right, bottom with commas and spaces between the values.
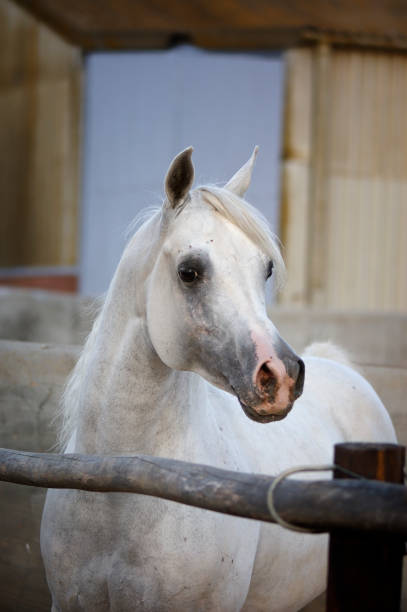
81, 47, 283, 294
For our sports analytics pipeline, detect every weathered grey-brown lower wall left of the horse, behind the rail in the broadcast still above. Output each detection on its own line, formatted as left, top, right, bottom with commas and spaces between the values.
0, 340, 79, 612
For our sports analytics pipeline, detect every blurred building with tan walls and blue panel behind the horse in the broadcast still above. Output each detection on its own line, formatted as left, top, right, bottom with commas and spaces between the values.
0, 0, 407, 311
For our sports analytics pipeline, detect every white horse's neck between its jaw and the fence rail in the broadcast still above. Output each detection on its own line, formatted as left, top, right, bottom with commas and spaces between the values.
72, 220, 207, 456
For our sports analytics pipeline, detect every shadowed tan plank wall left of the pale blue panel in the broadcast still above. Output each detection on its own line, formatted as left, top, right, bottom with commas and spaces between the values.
0, 0, 82, 267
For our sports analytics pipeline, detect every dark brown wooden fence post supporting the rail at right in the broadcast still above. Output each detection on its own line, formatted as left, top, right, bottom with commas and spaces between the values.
326, 443, 405, 612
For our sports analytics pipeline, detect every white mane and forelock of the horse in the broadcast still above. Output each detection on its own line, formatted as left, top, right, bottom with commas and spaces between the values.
56, 185, 285, 451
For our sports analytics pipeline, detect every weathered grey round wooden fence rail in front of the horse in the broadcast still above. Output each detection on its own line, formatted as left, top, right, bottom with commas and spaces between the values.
0, 449, 407, 538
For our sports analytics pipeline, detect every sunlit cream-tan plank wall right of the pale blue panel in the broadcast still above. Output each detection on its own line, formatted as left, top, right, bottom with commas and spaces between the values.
281, 45, 407, 312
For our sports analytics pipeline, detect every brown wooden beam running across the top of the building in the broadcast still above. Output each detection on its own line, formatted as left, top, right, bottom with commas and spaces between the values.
9, 0, 407, 50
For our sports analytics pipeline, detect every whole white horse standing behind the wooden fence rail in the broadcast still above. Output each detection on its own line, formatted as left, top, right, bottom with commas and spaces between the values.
41, 149, 395, 612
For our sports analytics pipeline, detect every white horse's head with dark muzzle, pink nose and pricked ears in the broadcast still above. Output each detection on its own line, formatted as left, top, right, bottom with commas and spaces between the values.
147, 147, 304, 423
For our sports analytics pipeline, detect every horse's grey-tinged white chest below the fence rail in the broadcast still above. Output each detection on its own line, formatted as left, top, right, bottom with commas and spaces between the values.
43, 492, 259, 612
